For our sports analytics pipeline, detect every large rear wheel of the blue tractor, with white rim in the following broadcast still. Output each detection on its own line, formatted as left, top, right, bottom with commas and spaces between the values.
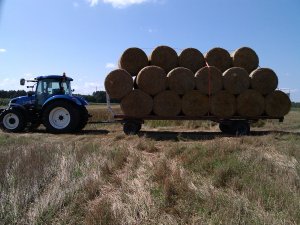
43, 101, 80, 134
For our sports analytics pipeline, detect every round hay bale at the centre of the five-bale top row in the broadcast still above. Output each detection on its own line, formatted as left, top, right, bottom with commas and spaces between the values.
179, 48, 205, 73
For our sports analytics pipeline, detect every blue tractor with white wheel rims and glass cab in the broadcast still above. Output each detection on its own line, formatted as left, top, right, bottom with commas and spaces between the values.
0, 73, 89, 133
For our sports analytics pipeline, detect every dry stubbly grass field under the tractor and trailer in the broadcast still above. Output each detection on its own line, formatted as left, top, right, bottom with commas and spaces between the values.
0, 105, 300, 225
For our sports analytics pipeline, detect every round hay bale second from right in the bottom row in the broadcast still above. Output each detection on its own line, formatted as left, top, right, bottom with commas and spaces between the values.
237, 89, 265, 117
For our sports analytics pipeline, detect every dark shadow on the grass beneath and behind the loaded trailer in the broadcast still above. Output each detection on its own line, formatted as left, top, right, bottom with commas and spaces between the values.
138, 131, 300, 141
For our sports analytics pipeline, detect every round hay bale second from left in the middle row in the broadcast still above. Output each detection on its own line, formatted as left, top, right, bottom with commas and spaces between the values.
136, 66, 167, 95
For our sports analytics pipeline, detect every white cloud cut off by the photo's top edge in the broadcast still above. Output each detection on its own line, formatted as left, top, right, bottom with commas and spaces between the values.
86, 0, 155, 8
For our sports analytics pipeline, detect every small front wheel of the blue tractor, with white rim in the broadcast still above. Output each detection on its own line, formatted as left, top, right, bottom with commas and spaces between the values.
0, 107, 26, 133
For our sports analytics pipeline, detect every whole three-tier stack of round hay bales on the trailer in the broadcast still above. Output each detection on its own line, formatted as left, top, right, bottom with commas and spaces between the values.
105, 46, 291, 118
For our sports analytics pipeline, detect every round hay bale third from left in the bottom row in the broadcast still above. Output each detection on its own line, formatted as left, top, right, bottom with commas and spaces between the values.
182, 90, 209, 116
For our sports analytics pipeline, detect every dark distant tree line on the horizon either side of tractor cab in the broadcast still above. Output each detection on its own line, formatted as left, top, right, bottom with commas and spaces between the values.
0, 90, 119, 103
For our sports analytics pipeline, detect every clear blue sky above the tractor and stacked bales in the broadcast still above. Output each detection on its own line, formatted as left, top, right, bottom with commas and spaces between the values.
0, 0, 300, 102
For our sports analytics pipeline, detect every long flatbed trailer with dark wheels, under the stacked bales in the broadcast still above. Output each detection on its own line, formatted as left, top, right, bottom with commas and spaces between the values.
113, 114, 284, 135
